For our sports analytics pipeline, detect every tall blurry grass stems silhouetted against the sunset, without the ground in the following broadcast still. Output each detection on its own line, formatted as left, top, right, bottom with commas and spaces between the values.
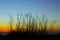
9, 13, 56, 34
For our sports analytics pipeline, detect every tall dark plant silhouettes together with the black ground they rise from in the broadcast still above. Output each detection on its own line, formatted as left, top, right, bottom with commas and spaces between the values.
0, 14, 60, 40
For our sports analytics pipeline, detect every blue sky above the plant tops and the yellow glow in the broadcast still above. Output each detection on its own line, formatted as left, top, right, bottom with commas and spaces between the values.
0, 0, 60, 21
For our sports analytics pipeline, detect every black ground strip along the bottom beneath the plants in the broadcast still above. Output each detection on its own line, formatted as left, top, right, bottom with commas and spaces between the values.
0, 32, 60, 40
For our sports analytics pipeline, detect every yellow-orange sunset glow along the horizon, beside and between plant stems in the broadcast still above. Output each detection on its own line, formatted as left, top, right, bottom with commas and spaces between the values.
0, 19, 60, 32
